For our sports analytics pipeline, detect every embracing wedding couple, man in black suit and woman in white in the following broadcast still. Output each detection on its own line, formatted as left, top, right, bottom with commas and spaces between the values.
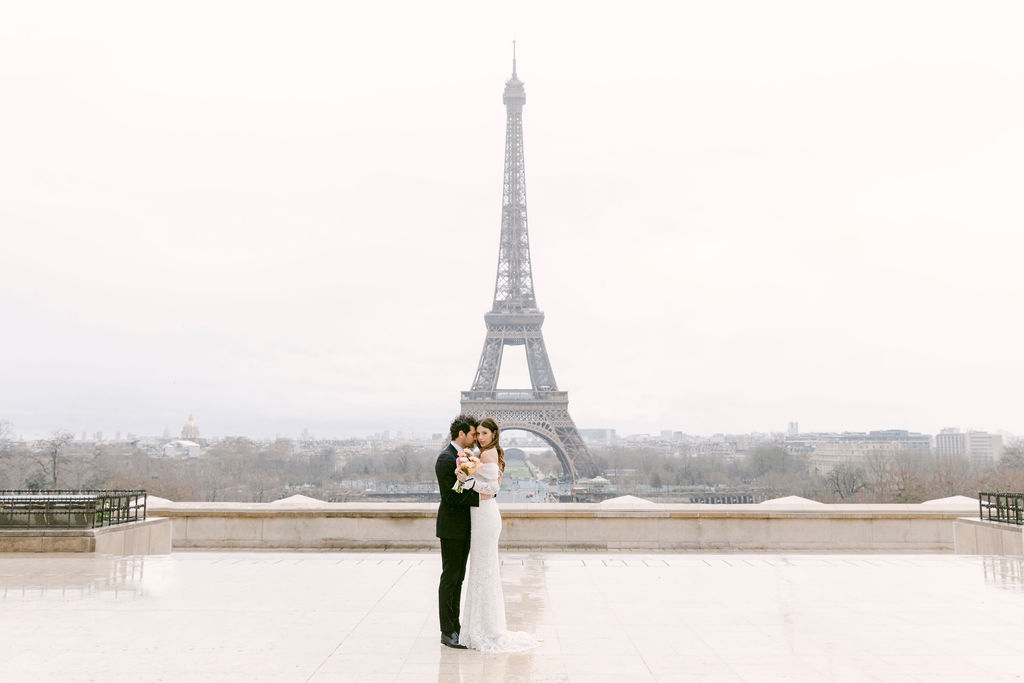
434, 415, 540, 652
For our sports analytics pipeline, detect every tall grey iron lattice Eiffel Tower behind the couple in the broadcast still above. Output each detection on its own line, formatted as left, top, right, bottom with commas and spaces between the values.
462, 50, 598, 481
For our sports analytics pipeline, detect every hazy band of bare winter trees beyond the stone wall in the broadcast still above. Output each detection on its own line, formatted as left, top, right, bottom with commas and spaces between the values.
0, 422, 1024, 503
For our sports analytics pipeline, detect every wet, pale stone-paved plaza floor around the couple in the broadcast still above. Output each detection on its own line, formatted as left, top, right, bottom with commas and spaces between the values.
0, 552, 1024, 683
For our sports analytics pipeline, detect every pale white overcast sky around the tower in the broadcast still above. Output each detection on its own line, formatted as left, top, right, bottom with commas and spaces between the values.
0, 0, 1024, 436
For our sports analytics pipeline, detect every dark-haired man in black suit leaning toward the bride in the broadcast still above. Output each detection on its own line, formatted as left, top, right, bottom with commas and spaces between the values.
434, 415, 480, 649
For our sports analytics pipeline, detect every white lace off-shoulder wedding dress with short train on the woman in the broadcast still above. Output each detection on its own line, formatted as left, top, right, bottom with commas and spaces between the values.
459, 463, 541, 652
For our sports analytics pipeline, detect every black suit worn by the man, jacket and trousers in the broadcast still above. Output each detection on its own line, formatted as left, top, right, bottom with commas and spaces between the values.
434, 443, 480, 634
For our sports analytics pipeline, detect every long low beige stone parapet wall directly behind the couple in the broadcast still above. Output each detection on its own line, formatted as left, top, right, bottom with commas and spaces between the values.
150, 503, 976, 552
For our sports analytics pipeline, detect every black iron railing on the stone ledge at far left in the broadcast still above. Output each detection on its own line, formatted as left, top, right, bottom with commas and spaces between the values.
0, 488, 145, 529
